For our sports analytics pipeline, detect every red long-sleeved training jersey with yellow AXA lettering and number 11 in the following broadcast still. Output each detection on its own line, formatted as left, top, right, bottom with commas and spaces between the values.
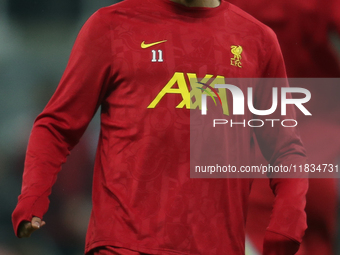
13, 0, 307, 255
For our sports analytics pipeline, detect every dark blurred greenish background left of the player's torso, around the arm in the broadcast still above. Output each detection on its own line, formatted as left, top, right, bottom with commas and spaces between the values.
0, 0, 118, 255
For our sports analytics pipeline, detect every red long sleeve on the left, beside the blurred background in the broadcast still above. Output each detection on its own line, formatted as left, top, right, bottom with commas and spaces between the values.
12, 10, 112, 237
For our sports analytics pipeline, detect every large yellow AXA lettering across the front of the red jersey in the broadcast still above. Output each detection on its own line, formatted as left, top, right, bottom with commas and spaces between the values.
147, 72, 229, 115
